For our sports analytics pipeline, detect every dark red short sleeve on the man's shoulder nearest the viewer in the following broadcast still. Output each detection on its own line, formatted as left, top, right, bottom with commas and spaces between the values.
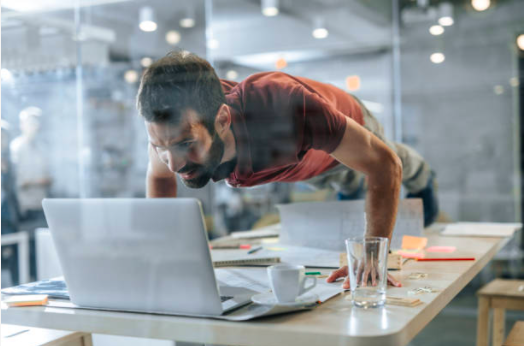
294, 87, 346, 153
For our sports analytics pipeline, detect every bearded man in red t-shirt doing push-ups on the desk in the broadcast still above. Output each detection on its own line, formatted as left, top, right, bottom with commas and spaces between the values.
137, 51, 436, 288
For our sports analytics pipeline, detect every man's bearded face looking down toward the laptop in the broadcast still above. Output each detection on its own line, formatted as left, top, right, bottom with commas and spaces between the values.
146, 110, 224, 188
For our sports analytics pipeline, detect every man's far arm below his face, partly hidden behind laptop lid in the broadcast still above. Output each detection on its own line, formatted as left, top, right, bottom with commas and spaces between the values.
146, 144, 176, 198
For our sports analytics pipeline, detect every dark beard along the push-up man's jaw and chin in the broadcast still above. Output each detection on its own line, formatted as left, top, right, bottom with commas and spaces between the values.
178, 133, 224, 189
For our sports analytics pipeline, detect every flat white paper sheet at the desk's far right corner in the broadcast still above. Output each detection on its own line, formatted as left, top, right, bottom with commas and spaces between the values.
441, 222, 522, 237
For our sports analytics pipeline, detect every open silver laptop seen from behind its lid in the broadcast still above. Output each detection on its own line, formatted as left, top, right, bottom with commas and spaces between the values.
42, 198, 256, 316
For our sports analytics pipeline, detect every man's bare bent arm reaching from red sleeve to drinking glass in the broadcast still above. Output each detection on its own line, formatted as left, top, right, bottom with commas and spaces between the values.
331, 118, 402, 240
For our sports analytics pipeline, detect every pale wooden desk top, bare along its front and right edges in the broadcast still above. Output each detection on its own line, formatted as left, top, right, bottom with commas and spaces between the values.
2, 228, 508, 346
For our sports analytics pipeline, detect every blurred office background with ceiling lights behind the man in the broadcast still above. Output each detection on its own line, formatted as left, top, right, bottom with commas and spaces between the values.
1, 0, 524, 345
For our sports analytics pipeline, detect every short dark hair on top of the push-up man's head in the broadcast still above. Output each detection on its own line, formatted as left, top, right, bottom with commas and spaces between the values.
137, 50, 226, 134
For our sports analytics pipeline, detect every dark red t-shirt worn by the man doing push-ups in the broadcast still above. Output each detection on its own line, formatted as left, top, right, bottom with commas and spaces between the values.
217, 72, 364, 187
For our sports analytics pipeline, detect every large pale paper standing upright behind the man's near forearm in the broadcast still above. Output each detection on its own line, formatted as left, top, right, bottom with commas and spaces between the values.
278, 198, 424, 252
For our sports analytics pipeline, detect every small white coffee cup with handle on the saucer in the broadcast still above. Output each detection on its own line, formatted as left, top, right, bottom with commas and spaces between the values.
267, 264, 317, 303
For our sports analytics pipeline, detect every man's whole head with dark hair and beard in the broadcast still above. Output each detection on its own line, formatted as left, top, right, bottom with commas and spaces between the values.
137, 51, 230, 188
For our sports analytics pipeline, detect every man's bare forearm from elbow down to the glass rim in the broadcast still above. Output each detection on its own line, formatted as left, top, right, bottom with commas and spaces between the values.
366, 166, 402, 240
